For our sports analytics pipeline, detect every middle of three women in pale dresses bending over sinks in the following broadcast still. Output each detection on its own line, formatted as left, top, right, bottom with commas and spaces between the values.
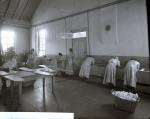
103, 57, 120, 86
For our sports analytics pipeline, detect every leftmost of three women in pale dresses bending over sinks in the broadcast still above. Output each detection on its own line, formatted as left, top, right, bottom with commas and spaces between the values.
79, 57, 95, 79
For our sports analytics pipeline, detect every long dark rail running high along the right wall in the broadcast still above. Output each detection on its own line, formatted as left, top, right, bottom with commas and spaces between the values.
32, 0, 131, 27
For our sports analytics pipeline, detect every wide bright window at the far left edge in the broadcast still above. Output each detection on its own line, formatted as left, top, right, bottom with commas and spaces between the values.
1, 31, 15, 52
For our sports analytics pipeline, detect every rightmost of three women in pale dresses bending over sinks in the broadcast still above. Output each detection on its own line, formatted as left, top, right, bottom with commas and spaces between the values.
124, 60, 140, 88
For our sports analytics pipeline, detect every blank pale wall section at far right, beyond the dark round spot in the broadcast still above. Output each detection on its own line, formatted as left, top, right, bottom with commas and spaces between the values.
117, 0, 148, 56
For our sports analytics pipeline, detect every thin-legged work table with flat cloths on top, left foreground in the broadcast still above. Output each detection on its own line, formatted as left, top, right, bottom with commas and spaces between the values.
0, 69, 55, 103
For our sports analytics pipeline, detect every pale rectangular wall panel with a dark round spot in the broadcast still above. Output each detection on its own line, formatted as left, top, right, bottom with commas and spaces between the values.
100, 5, 118, 44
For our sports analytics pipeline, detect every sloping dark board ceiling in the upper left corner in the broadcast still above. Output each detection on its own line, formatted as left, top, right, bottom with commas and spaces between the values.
0, 0, 41, 22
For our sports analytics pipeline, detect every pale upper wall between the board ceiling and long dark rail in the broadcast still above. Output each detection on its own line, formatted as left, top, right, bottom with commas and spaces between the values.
32, 0, 117, 24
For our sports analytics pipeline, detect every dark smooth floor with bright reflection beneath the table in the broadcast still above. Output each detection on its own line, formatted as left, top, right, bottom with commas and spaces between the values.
0, 77, 150, 119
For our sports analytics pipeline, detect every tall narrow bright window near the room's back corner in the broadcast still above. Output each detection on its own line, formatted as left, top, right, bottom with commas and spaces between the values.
38, 30, 46, 56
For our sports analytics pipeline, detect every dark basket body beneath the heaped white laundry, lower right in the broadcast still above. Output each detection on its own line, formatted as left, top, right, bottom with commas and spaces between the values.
114, 96, 140, 112
